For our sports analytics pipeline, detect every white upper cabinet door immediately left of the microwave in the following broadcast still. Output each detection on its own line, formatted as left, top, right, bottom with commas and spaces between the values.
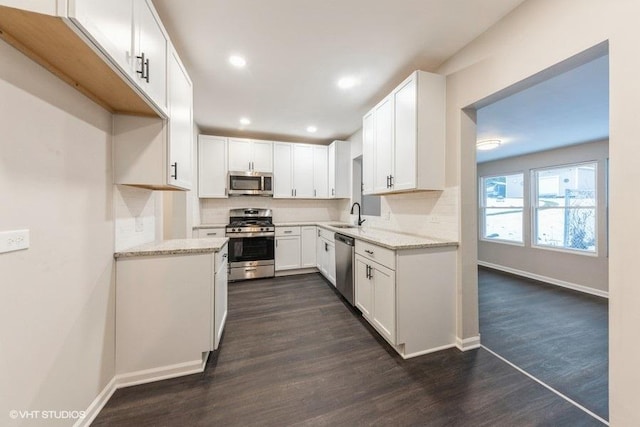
198, 135, 227, 199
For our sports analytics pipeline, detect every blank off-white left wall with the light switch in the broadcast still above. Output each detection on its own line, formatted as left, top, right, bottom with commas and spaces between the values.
0, 42, 114, 426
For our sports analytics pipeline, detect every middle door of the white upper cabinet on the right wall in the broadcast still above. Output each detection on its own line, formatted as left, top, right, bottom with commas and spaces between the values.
373, 96, 393, 193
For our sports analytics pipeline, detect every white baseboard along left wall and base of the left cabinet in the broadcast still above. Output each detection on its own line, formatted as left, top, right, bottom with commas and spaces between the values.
73, 358, 209, 427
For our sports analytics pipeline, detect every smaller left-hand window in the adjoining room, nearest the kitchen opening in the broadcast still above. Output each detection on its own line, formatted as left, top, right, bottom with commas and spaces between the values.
480, 173, 524, 243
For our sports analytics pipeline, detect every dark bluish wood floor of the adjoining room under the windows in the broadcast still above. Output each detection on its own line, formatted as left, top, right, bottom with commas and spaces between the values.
478, 267, 609, 419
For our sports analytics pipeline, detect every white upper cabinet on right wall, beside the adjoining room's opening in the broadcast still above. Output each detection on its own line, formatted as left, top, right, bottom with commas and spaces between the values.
363, 71, 445, 194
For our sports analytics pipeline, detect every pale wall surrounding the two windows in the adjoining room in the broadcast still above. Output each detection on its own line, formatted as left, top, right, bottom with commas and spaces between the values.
478, 141, 609, 295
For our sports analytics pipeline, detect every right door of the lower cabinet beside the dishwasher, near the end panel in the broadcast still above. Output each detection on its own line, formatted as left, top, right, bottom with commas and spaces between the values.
371, 263, 396, 344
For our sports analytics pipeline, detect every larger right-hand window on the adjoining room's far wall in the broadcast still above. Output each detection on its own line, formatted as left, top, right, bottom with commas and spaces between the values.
532, 162, 597, 253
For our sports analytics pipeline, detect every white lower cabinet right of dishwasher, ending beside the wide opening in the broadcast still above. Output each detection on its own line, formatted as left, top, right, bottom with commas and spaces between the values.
355, 240, 456, 358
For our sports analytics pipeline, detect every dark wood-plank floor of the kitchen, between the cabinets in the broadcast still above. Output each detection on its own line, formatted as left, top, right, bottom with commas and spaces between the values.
93, 274, 601, 426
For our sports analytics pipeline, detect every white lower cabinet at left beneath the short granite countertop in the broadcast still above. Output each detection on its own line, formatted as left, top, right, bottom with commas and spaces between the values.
116, 245, 227, 382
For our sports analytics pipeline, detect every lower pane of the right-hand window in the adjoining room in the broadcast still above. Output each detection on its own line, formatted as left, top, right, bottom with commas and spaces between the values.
536, 208, 596, 252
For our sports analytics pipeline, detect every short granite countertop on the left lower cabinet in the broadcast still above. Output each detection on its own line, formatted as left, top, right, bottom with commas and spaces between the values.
113, 237, 229, 258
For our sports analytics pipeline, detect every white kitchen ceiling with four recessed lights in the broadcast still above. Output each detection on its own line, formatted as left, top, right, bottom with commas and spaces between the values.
153, 0, 523, 142
